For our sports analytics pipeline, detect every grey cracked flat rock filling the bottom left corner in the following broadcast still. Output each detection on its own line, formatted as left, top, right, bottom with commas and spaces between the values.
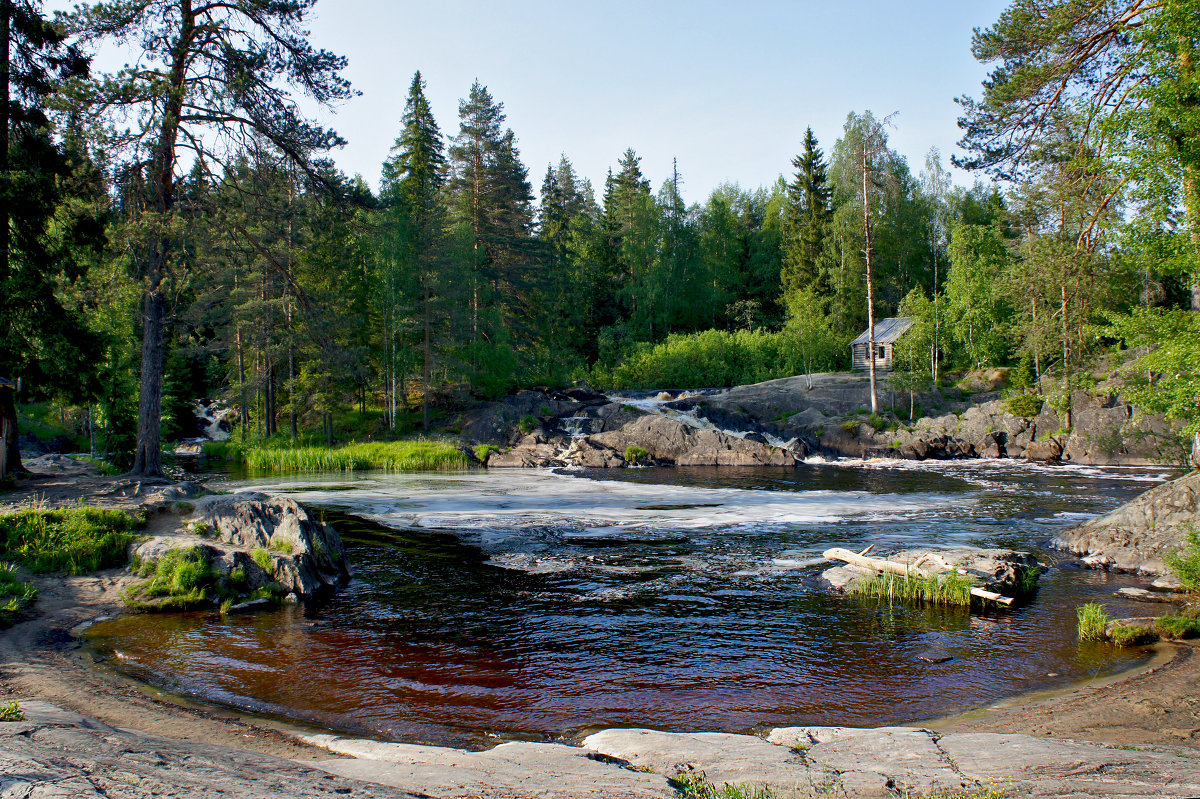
0, 702, 415, 799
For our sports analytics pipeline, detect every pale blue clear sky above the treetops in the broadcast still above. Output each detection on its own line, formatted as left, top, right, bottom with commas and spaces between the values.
47, 0, 1007, 202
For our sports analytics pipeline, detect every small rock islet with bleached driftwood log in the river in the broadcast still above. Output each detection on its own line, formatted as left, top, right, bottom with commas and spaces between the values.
822, 545, 1040, 607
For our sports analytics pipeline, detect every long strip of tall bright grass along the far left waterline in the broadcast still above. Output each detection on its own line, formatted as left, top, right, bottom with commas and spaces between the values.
242, 440, 469, 471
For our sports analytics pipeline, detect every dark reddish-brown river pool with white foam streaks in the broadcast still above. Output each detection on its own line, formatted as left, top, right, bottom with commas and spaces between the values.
90, 461, 1170, 746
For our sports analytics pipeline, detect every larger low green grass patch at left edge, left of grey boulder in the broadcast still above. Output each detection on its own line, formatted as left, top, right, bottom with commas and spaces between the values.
0, 507, 142, 575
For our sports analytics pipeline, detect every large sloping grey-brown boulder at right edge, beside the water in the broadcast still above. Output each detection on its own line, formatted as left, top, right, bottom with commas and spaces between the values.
1051, 471, 1200, 575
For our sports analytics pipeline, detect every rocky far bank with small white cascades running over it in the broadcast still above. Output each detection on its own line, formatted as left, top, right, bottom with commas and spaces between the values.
460, 374, 1187, 468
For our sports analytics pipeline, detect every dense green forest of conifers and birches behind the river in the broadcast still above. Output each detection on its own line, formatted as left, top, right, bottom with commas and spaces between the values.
0, 0, 1200, 473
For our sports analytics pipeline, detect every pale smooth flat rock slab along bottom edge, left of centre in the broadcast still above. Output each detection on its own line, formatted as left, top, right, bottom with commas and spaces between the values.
305, 735, 672, 799
